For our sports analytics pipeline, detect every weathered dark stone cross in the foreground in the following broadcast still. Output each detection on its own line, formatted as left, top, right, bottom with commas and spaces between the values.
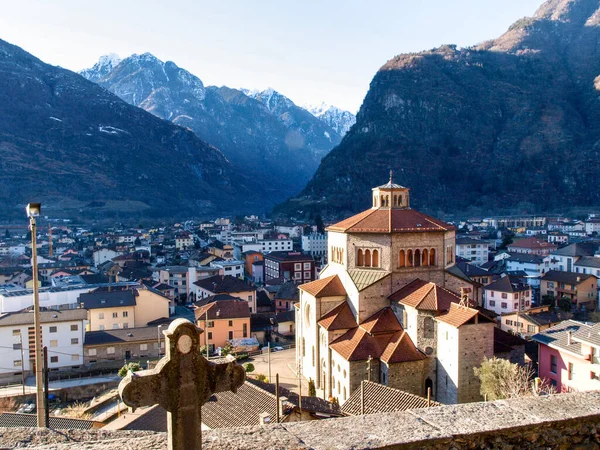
119, 319, 246, 450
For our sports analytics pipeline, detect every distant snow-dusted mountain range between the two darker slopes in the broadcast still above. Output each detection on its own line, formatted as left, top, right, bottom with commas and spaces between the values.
81, 53, 341, 206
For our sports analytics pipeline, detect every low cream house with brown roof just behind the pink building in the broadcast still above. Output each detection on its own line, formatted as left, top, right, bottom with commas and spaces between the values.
500, 305, 570, 337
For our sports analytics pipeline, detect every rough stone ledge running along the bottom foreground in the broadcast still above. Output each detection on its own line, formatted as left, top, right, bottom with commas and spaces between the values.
0, 392, 600, 450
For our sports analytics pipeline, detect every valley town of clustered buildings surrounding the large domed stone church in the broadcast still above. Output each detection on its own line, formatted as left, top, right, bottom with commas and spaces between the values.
0, 175, 600, 431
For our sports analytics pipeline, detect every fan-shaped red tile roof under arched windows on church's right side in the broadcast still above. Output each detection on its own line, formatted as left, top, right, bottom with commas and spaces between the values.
390, 278, 460, 312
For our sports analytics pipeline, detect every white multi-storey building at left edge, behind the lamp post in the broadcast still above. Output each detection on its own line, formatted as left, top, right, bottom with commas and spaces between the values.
0, 309, 87, 376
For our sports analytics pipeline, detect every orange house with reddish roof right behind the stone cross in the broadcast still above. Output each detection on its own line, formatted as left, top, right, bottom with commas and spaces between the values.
194, 294, 250, 351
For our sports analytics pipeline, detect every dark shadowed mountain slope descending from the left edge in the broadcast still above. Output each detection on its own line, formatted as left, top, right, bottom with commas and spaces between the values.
0, 40, 255, 218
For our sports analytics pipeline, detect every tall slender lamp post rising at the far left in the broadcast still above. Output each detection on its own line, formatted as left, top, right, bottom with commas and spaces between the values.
25, 203, 46, 428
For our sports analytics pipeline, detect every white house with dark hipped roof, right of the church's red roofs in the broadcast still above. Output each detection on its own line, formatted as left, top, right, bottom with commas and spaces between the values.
483, 275, 532, 315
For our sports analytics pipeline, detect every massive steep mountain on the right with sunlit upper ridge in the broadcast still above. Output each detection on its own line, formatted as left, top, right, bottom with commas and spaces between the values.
276, 0, 600, 217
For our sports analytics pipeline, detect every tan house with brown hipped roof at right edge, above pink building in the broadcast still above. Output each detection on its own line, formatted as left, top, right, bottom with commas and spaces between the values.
540, 270, 598, 309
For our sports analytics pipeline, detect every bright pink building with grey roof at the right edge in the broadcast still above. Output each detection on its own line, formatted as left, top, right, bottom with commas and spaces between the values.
532, 320, 600, 392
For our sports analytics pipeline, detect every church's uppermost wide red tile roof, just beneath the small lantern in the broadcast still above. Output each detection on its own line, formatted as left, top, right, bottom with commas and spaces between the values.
327, 208, 455, 233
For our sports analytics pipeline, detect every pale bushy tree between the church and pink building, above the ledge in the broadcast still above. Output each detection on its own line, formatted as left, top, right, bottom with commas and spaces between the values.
473, 357, 554, 401
